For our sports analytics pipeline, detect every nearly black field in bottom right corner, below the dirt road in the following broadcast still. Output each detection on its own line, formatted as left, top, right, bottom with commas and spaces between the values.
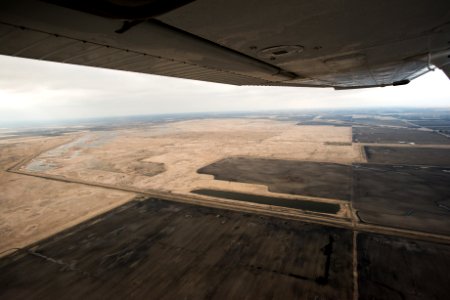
357, 233, 450, 300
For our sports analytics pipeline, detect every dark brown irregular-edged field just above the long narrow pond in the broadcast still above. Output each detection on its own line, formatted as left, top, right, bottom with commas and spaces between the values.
197, 157, 352, 200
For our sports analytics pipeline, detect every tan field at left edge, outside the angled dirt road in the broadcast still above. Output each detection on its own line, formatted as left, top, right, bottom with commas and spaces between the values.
0, 136, 135, 256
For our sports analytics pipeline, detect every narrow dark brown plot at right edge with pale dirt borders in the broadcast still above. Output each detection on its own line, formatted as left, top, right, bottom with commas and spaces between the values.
364, 146, 450, 166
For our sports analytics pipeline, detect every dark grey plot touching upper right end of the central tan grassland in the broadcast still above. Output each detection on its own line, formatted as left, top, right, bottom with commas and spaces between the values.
352, 127, 450, 145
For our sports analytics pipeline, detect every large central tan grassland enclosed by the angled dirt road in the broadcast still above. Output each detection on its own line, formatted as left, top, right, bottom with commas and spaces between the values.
21, 120, 362, 193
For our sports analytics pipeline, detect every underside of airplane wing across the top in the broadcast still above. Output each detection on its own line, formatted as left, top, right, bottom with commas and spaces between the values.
0, 0, 450, 89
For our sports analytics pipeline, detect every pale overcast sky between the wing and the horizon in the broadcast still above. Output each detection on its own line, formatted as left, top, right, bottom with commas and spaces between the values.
0, 56, 450, 122
